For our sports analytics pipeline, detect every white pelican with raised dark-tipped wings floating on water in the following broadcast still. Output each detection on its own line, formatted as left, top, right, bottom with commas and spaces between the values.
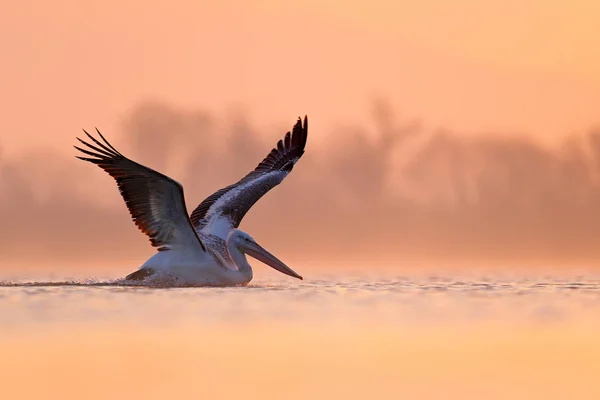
74, 116, 308, 286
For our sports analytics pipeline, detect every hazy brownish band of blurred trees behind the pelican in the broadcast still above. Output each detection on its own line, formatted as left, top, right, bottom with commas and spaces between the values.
0, 99, 600, 269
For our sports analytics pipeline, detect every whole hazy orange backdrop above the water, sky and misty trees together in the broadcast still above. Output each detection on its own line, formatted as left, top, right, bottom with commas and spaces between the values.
0, 0, 600, 273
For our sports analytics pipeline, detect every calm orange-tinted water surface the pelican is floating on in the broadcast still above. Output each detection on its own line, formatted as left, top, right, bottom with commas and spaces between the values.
0, 276, 600, 399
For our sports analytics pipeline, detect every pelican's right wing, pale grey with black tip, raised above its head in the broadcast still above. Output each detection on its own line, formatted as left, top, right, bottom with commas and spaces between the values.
191, 116, 308, 238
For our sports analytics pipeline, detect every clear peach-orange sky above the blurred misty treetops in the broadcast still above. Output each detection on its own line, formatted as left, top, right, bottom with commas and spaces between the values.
0, 0, 600, 153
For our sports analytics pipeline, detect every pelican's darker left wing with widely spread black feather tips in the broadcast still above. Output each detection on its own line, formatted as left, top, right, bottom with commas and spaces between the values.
74, 129, 206, 251
